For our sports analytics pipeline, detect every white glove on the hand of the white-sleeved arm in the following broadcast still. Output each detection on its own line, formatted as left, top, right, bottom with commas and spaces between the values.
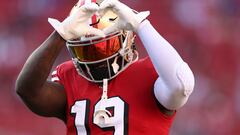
99, 0, 150, 33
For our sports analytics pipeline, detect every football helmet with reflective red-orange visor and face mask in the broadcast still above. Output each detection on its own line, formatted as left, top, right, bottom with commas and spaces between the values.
66, 0, 138, 83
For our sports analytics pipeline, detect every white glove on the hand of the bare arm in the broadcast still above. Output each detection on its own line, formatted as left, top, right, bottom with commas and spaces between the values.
48, 3, 105, 40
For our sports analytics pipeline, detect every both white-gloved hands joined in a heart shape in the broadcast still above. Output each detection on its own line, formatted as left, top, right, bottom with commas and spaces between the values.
48, 0, 150, 40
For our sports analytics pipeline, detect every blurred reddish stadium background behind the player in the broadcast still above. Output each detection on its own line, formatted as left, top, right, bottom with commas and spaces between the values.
0, 0, 240, 135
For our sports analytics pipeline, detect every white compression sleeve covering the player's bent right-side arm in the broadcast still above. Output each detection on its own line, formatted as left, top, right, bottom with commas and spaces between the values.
137, 20, 194, 110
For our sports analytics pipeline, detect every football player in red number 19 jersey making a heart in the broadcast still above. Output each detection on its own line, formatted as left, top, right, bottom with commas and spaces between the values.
16, 0, 194, 135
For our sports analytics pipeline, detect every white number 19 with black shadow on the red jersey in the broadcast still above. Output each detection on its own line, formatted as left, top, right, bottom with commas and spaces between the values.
71, 97, 128, 135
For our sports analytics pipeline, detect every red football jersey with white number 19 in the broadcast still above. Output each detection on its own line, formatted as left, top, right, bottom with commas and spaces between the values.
53, 57, 174, 135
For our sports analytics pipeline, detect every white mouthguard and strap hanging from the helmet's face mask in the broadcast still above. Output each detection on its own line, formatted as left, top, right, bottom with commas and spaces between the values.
93, 79, 112, 127
